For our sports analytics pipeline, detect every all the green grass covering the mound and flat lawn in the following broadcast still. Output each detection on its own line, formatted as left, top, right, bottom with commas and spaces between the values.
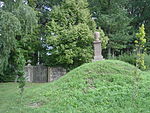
0, 60, 150, 113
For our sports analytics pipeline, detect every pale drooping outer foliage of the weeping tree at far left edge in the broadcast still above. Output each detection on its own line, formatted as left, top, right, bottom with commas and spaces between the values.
0, 10, 21, 75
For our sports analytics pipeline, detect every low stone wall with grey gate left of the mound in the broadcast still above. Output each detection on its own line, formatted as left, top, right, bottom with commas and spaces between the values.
24, 65, 66, 83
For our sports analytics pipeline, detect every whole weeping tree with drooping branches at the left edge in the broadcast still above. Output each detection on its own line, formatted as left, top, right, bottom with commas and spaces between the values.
0, 0, 37, 81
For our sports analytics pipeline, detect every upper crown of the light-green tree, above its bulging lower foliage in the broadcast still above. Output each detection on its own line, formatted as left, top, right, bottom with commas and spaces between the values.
50, 0, 95, 30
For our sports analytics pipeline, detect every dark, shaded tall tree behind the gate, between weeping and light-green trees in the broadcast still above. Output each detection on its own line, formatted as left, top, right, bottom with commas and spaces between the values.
26, 0, 62, 65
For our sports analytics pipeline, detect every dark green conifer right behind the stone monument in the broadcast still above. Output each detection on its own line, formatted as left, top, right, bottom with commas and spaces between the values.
89, 0, 131, 55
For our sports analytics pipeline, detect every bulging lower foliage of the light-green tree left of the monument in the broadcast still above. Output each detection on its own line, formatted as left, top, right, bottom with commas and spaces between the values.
48, 24, 93, 69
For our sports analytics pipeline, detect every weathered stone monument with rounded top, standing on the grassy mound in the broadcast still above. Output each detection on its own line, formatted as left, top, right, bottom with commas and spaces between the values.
93, 32, 103, 61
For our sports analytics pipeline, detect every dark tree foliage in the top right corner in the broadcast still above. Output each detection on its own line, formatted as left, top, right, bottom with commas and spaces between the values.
128, 0, 150, 53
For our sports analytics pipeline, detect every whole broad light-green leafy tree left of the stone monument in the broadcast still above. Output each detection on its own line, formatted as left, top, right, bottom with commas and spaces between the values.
47, 0, 95, 68
